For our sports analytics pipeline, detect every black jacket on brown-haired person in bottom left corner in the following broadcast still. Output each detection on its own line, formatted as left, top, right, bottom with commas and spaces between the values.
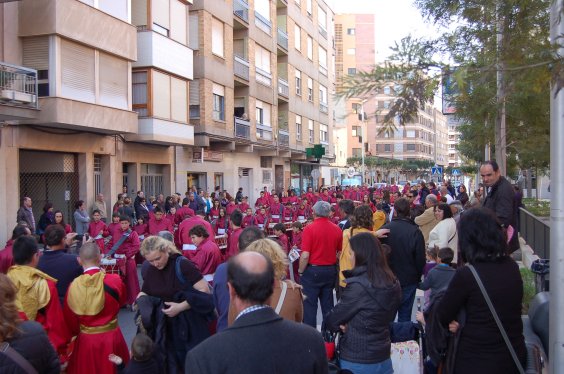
0, 321, 61, 374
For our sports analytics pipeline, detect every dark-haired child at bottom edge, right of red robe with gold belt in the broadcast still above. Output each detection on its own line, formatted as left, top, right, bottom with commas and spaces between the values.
108, 333, 163, 374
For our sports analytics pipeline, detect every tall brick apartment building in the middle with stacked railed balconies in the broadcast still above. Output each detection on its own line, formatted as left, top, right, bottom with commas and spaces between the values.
182, 0, 334, 201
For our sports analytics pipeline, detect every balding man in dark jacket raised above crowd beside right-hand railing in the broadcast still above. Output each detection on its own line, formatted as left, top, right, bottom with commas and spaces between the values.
480, 160, 519, 253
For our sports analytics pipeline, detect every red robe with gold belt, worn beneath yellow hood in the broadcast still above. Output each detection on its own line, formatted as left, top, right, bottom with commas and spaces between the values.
64, 269, 129, 374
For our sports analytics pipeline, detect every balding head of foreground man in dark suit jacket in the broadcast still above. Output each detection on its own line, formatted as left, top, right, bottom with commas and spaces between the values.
227, 252, 274, 312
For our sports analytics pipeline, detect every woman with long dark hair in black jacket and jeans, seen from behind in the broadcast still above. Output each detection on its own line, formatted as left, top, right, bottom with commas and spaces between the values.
325, 233, 401, 374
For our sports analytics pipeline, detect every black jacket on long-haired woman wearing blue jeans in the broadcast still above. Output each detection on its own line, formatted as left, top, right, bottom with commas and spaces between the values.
325, 266, 401, 364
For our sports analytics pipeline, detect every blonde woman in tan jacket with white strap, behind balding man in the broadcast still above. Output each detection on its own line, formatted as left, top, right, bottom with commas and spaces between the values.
228, 239, 303, 326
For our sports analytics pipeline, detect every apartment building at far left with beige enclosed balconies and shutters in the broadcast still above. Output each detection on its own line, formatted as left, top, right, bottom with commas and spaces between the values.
0, 0, 194, 241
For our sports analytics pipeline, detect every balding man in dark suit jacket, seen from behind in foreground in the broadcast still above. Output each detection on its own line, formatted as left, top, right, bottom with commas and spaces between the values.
185, 252, 328, 374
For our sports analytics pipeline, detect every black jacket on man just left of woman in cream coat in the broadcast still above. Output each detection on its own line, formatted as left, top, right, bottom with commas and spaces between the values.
380, 218, 425, 287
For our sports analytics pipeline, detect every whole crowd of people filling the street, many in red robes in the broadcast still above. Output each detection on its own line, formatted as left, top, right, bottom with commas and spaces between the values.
0, 161, 525, 374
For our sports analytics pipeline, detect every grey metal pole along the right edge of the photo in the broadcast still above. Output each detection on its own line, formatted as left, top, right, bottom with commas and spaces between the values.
548, 0, 564, 374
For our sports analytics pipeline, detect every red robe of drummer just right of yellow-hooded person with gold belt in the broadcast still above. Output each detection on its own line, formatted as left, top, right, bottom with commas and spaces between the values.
109, 229, 140, 304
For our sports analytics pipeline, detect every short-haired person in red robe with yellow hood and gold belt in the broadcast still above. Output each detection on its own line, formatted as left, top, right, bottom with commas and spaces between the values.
63, 243, 129, 374
